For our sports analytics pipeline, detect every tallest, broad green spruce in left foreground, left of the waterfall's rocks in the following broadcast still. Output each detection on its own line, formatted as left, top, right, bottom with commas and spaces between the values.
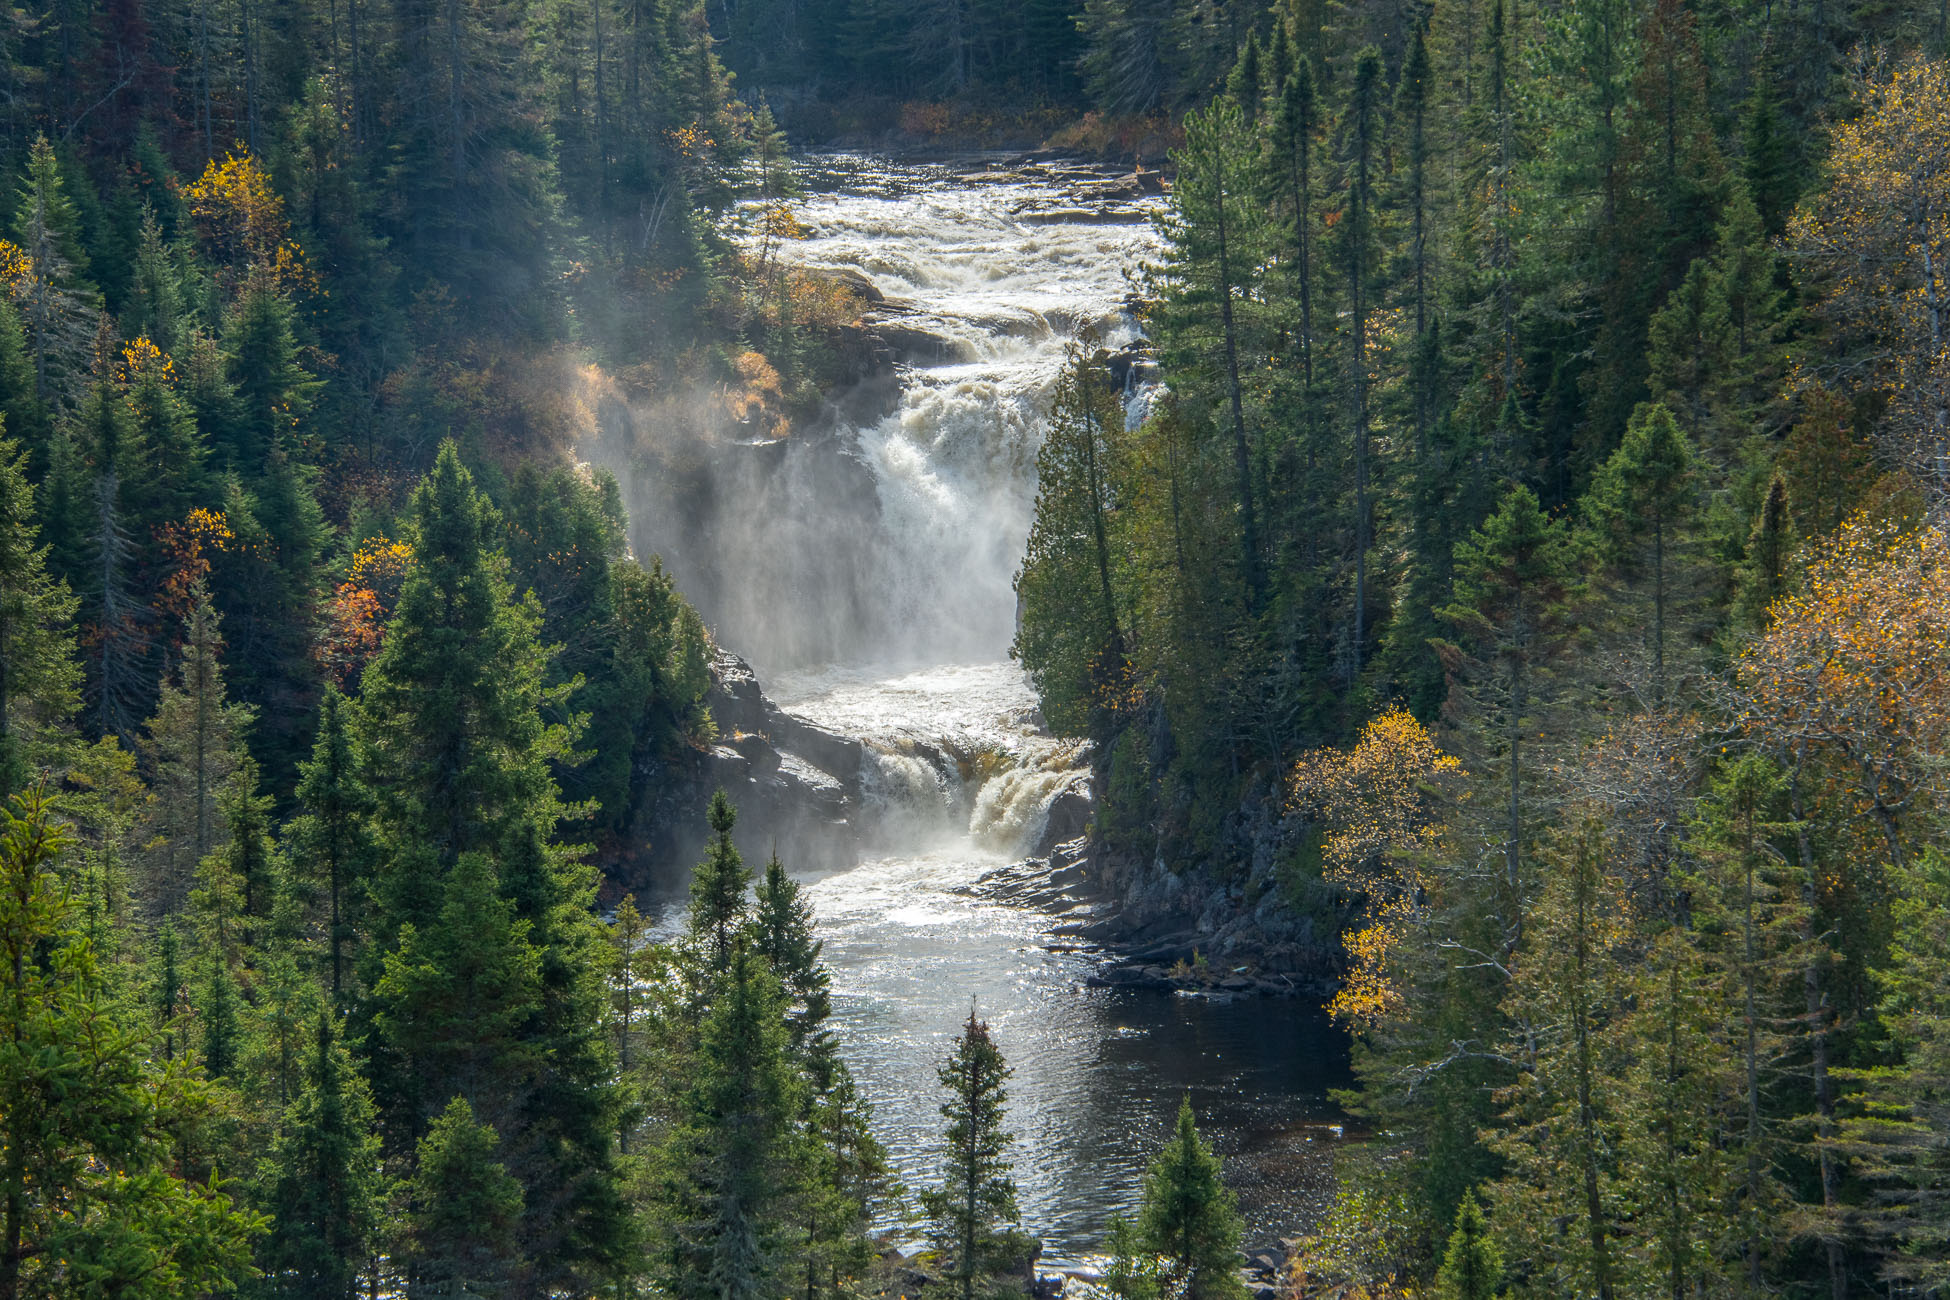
359, 442, 628, 1286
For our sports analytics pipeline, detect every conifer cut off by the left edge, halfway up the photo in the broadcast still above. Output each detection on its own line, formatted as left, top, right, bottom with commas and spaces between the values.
0, 437, 80, 799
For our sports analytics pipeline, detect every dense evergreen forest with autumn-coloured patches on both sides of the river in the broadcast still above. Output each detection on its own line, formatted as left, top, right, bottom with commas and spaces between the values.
0, 0, 1950, 1300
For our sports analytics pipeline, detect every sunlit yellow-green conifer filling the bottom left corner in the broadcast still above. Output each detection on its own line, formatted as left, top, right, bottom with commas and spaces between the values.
0, 795, 263, 1300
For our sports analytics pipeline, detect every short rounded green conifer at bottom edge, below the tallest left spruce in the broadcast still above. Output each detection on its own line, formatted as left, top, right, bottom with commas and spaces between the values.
402, 1095, 523, 1296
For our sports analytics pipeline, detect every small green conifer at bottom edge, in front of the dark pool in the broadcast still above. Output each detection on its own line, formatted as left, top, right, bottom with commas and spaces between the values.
1137, 1095, 1246, 1300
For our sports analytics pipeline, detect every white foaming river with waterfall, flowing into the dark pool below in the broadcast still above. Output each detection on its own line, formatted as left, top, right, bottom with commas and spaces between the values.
631, 156, 1346, 1263
